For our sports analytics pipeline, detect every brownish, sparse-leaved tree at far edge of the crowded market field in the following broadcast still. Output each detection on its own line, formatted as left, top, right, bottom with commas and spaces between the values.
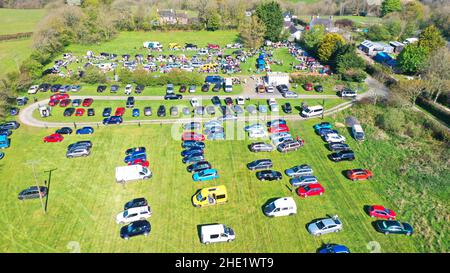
239, 15, 266, 48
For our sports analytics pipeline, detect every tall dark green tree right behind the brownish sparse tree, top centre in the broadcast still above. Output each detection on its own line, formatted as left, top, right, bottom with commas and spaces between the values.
256, 1, 284, 42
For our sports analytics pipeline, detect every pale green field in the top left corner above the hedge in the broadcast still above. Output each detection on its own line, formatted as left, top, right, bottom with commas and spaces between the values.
0, 8, 47, 35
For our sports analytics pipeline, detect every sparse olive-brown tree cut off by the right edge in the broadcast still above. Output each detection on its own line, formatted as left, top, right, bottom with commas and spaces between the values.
424, 47, 450, 102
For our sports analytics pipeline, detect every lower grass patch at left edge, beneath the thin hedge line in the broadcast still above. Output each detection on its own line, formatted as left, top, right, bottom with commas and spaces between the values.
0, 39, 31, 78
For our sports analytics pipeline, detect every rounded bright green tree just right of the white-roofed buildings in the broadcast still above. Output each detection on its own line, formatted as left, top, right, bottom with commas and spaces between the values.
397, 44, 428, 74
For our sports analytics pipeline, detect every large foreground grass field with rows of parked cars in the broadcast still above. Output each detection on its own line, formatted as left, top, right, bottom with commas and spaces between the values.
0, 107, 428, 252
